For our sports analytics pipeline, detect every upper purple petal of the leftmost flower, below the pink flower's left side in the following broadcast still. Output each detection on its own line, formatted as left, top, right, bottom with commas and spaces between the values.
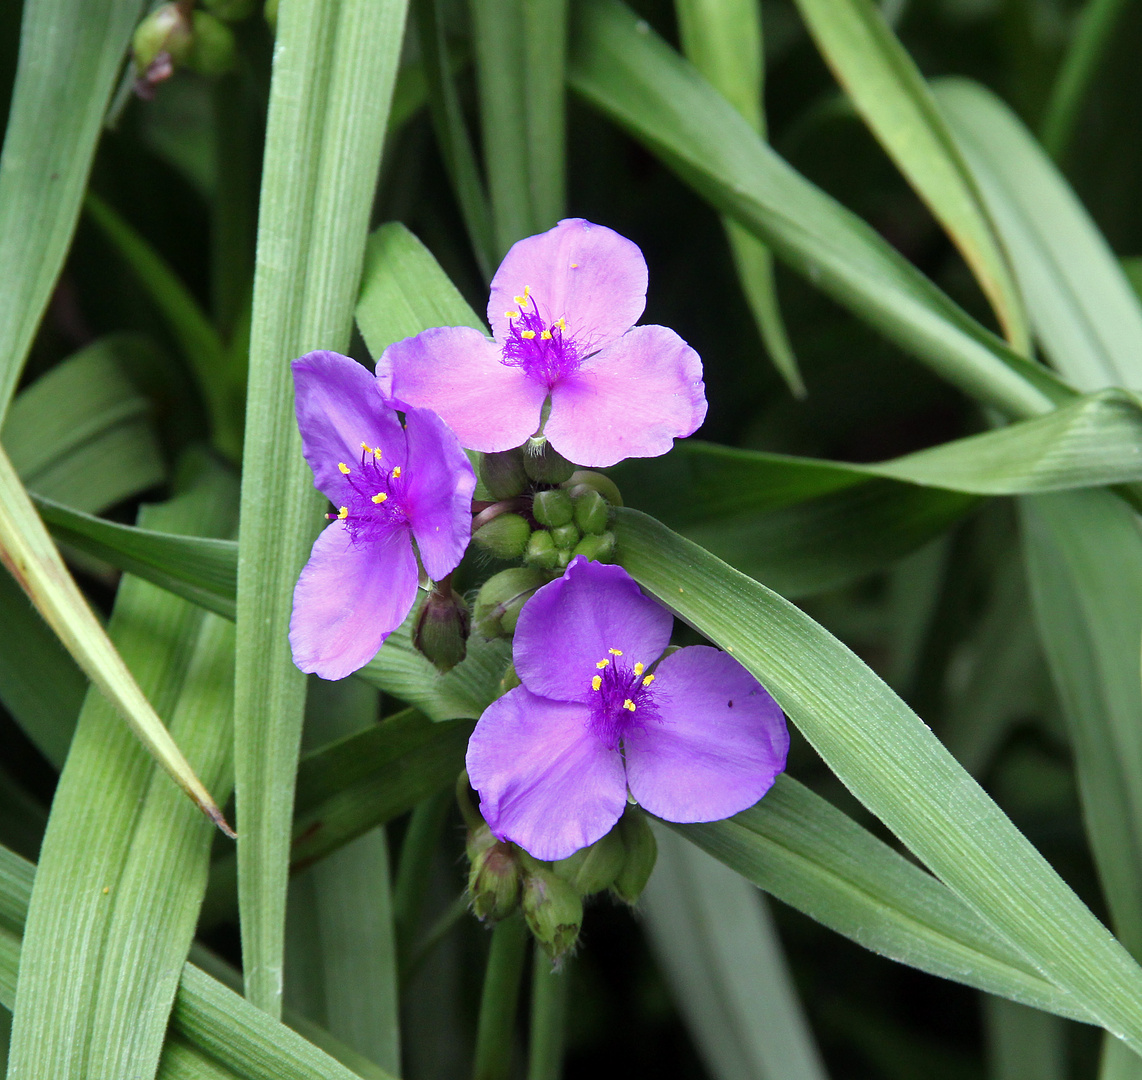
291, 350, 404, 501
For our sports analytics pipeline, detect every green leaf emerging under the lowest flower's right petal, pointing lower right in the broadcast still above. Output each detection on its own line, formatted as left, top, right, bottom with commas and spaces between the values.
674, 775, 1089, 1019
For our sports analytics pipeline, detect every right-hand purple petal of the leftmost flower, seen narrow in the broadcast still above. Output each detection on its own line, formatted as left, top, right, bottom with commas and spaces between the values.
402, 409, 476, 581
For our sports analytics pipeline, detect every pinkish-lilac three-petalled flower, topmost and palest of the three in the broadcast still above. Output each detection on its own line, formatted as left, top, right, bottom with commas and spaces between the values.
377, 218, 706, 467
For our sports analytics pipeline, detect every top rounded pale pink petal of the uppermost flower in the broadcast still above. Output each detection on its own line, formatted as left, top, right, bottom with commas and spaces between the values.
488, 218, 646, 351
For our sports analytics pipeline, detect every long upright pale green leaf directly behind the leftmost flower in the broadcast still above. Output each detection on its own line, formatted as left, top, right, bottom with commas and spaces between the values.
234, 0, 405, 1016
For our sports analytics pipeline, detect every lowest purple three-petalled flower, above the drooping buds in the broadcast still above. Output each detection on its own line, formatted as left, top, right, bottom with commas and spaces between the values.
467, 556, 789, 860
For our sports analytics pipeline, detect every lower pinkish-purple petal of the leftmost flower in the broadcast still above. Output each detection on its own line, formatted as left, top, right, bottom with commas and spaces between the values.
289, 522, 417, 679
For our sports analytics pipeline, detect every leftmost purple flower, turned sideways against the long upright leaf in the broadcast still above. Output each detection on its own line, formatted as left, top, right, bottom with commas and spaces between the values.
289, 352, 476, 679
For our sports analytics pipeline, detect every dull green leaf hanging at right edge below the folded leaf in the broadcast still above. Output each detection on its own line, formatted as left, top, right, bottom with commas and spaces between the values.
1020, 491, 1142, 956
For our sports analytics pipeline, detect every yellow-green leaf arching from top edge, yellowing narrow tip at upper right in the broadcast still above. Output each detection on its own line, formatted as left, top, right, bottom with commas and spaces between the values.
797, 0, 1030, 353
